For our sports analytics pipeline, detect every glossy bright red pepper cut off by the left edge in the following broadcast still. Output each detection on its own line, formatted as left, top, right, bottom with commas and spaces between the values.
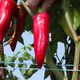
0, 0, 16, 41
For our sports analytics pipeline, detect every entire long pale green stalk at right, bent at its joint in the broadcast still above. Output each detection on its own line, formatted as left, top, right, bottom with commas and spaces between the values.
62, 0, 80, 80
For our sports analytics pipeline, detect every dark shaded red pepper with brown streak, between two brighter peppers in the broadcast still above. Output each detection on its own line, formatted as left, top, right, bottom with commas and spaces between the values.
9, 5, 27, 51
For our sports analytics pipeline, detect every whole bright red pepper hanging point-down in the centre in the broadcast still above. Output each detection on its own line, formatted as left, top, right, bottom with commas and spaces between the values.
33, 12, 49, 68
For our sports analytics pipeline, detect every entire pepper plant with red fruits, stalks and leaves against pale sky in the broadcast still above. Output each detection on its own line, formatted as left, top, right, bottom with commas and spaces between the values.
0, 0, 80, 80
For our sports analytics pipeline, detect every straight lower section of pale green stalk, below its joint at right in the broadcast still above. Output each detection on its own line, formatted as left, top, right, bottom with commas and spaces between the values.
72, 42, 80, 80
